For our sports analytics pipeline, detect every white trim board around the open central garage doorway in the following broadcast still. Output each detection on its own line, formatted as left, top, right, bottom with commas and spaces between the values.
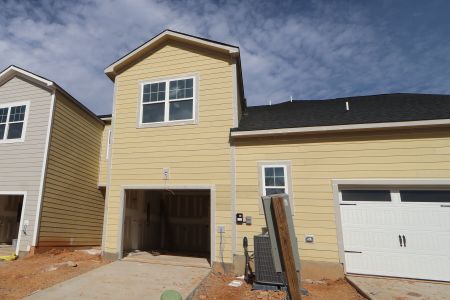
117, 184, 216, 266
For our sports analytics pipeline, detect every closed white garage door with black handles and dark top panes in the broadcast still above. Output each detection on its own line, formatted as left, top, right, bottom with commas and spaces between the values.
339, 187, 450, 281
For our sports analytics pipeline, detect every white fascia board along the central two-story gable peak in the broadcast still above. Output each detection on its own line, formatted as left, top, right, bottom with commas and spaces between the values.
104, 31, 239, 74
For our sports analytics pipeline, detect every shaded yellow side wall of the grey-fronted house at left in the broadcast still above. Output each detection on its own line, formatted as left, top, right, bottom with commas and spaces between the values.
38, 93, 104, 246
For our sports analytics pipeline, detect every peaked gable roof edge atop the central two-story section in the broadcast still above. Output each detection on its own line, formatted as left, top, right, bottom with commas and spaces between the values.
105, 29, 239, 81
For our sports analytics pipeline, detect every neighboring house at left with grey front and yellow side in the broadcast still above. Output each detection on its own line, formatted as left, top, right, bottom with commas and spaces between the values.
0, 66, 104, 254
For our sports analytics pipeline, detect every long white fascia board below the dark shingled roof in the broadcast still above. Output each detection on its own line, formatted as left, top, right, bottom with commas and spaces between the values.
230, 119, 450, 138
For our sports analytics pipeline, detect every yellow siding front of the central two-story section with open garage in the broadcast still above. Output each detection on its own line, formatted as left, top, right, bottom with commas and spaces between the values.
105, 41, 233, 262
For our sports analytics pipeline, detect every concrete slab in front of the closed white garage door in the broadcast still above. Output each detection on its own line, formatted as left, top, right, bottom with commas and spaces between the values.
347, 275, 450, 300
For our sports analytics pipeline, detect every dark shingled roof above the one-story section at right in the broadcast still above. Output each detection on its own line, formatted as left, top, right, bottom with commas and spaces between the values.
231, 93, 450, 136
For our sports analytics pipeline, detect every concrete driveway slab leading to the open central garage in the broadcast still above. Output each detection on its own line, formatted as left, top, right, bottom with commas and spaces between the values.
26, 261, 210, 300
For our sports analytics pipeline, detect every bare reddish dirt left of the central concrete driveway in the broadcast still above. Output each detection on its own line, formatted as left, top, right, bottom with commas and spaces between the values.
0, 250, 108, 299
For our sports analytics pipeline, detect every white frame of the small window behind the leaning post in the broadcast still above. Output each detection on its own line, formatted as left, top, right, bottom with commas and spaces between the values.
257, 161, 295, 215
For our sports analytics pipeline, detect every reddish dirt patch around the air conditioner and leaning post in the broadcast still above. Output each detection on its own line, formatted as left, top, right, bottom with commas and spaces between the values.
193, 272, 365, 300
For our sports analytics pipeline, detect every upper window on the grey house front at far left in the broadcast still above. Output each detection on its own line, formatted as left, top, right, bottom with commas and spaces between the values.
0, 103, 28, 142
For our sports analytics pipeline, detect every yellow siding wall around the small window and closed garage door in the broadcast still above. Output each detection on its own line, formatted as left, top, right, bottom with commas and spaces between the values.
236, 129, 450, 262
